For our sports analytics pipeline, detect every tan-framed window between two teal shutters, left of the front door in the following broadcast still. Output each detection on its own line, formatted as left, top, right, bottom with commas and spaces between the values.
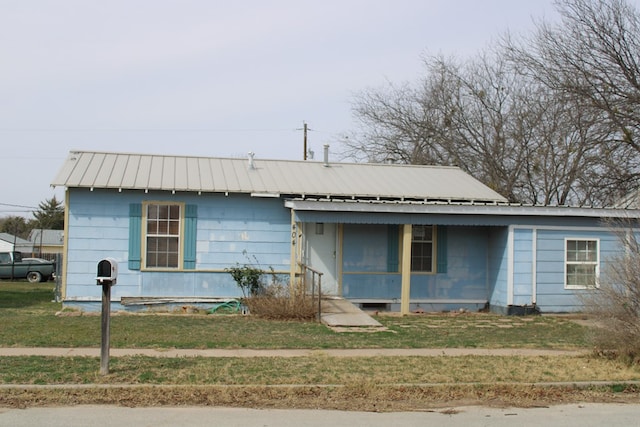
145, 203, 181, 268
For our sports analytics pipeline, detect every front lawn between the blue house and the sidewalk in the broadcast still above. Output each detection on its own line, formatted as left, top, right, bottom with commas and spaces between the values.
0, 282, 588, 349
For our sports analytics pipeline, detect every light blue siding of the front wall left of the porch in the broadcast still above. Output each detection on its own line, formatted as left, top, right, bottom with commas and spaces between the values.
65, 189, 291, 300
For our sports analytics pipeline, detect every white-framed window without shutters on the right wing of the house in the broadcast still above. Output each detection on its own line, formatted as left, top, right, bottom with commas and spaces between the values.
565, 239, 600, 289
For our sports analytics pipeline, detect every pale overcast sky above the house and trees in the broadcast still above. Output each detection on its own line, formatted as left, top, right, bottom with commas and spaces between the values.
0, 0, 556, 217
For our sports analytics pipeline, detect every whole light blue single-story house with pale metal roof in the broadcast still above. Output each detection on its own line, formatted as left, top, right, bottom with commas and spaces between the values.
53, 152, 640, 313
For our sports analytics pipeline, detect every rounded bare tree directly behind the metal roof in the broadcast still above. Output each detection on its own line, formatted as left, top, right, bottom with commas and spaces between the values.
348, 51, 633, 205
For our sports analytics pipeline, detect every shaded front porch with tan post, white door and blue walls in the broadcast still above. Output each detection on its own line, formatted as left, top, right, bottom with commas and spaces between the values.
296, 217, 507, 314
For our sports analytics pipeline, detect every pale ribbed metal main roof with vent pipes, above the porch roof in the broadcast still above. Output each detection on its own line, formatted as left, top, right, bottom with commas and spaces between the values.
51, 151, 506, 202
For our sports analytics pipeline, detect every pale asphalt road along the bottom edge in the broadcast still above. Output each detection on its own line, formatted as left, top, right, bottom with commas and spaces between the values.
0, 403, 640, 427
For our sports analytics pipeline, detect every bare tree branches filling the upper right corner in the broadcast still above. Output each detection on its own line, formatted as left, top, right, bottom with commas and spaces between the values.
503, 0, 640, 151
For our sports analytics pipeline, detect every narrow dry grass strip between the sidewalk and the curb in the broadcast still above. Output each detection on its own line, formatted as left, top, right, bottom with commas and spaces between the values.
0, 355, 640, 391
